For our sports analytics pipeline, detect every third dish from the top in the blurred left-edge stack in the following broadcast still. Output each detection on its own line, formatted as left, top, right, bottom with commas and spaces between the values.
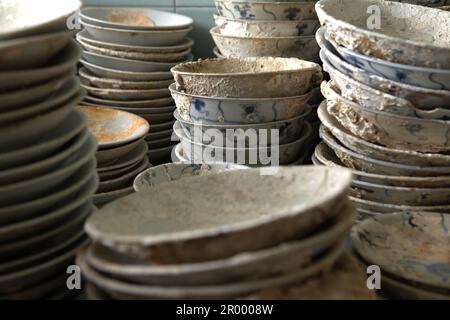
0, 40, 81, 91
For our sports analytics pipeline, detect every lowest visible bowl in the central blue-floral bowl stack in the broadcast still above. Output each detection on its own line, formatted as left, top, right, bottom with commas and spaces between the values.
175, 122, 312, 166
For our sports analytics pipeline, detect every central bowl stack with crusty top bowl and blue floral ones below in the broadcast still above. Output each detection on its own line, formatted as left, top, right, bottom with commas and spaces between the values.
170, 57, 322, 166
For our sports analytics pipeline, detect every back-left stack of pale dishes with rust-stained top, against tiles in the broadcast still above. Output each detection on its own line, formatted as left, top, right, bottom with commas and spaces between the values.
77, 7, 193, 164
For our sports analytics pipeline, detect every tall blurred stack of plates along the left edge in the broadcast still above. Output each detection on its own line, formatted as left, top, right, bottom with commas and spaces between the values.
0, 0, 98, 299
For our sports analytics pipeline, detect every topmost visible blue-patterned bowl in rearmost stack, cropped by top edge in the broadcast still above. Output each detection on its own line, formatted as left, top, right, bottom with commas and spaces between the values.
214, 0, 317, 21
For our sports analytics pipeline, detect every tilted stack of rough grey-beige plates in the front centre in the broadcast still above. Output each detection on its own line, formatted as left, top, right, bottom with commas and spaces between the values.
77, 167, 356, 299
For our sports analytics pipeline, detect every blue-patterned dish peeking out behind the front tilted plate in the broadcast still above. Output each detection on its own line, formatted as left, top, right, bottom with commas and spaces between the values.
133, 162, 247, 192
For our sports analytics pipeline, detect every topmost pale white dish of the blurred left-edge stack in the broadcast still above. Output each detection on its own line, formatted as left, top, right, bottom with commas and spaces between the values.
0, 0, 81, 40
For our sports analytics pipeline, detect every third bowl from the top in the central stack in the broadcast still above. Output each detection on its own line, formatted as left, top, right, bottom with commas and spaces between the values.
174, 108, 311, 147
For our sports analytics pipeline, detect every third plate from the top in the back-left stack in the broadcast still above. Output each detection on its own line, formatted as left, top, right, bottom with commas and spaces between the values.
78, 39, 191, 63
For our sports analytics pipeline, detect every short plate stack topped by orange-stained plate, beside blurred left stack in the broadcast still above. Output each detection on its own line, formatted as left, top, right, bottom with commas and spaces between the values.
78, 106, 150, 207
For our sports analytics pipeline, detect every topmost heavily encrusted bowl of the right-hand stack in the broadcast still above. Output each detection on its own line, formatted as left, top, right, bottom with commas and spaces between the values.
316, 0, 450, 69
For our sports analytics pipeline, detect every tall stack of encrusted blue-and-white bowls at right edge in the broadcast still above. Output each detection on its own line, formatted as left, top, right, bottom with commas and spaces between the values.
315, 0, 450, 219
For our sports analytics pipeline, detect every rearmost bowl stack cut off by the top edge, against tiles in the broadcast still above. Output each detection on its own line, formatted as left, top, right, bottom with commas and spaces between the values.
210, 0, 320, 61
